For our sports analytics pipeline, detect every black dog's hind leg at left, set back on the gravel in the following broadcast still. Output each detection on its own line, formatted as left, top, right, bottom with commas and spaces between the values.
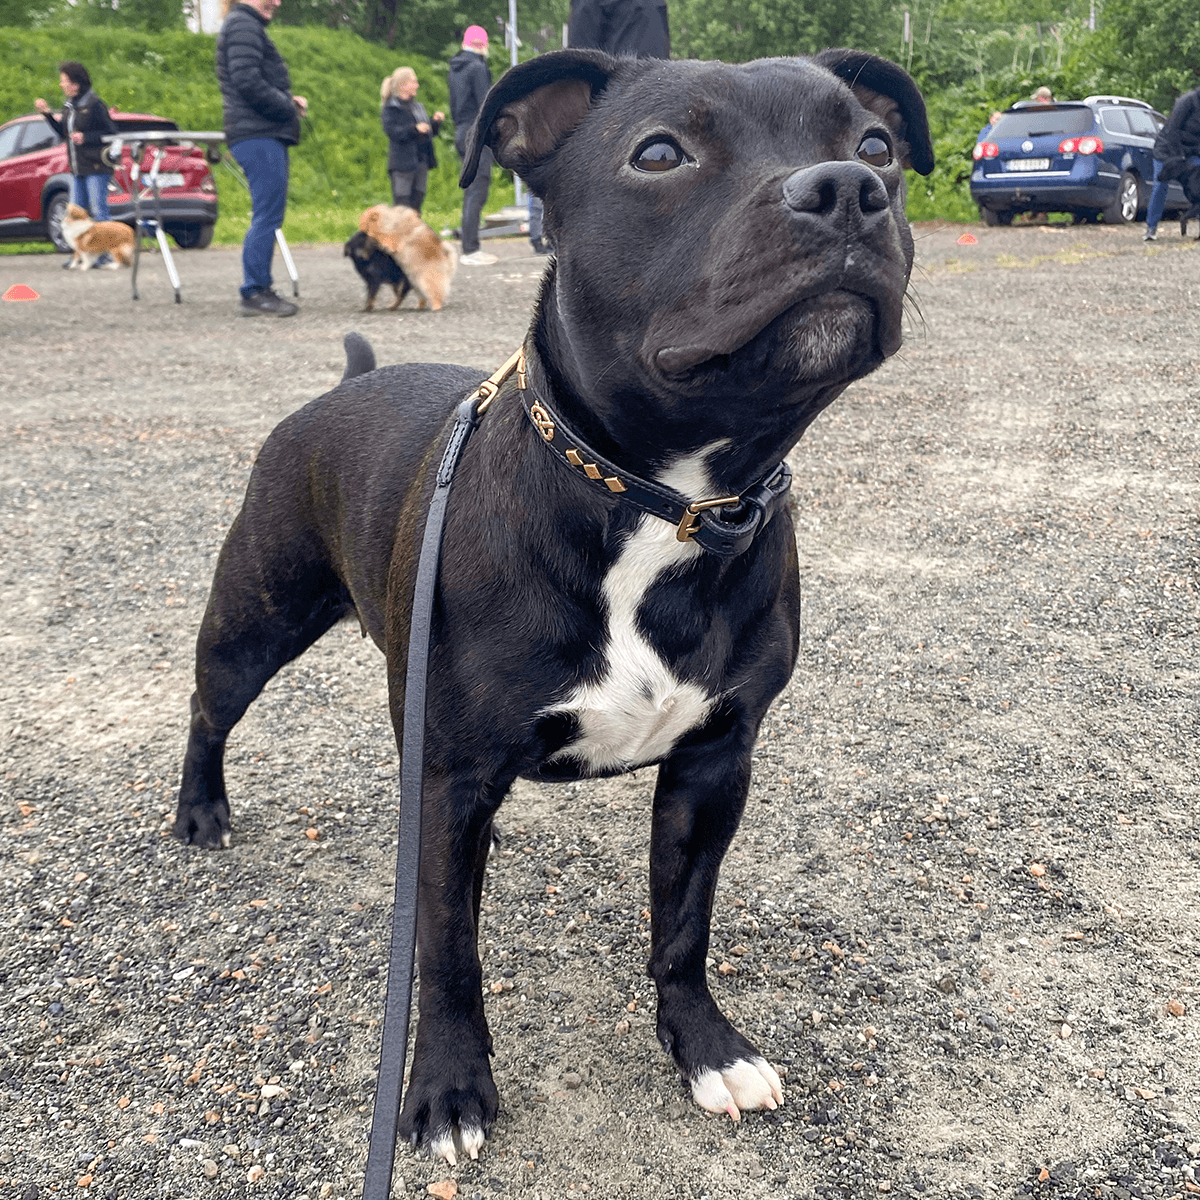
174, 511, 353, 847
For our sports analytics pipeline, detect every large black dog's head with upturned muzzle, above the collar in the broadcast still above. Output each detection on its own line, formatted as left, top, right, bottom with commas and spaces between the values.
463, 50, 932, 470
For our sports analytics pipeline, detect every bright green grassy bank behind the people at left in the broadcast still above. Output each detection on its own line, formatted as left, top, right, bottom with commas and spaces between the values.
0, 26, 512, 242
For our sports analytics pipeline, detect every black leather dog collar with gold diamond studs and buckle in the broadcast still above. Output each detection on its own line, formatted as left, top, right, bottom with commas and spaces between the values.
521, 386, 792, 558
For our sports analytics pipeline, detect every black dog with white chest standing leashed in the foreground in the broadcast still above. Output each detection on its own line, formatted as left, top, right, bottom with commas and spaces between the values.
175, 50, 932, 1162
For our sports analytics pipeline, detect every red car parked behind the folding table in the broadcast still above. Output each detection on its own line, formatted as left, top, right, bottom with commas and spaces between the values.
0, 113, 217, 251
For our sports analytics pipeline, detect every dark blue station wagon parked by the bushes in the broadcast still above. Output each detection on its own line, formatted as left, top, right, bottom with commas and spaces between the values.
971, 96, 1188, 226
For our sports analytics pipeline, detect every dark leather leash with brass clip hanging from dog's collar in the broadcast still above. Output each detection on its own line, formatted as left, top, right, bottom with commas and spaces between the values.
362, 348, 524, 1200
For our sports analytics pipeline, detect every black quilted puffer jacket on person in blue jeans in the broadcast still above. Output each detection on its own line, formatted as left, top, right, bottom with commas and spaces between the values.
217, 4, 300, 145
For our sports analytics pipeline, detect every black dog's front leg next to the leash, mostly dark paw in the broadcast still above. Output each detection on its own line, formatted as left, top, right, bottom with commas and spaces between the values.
401, 773, 499, 1164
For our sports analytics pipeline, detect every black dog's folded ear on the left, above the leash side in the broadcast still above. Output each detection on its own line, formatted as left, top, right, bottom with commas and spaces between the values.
460, 50, 618, 192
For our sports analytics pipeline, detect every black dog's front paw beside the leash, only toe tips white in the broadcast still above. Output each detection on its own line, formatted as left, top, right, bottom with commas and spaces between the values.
400, 1046, 500, 1166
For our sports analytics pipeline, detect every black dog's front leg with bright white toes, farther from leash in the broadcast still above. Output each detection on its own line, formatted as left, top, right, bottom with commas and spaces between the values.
649, 727, 784, 1121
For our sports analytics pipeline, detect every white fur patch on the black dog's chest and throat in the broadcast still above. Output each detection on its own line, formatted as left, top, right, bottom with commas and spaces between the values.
542, 442, 724, 770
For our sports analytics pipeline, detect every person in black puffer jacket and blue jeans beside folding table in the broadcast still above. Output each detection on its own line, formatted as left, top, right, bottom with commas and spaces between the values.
217, 0, 308, 317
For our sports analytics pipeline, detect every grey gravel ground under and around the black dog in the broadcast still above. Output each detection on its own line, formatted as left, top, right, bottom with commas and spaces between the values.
0, 218, 1200, 1200
